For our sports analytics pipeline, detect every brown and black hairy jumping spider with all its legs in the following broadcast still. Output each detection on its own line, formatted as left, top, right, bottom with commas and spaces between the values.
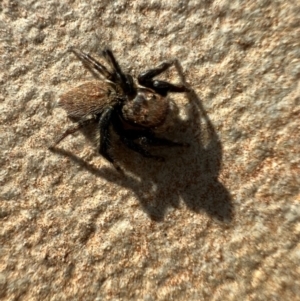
50, 48, 189, 166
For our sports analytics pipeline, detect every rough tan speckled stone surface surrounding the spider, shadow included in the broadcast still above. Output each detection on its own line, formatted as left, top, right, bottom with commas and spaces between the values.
0, 0, 300, 301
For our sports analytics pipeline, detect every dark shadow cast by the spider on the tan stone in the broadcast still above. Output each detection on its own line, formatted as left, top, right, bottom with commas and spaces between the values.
52, 63, 233, 222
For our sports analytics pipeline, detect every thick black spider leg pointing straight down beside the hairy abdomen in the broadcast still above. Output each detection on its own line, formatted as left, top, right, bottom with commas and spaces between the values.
98, 107, 114, 163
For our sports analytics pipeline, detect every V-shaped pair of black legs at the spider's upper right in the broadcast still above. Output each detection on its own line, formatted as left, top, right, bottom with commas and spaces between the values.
138, 61, 189, 96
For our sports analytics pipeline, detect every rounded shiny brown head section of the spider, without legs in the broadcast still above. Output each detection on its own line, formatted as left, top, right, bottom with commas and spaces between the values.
122, 89, 169, 128
